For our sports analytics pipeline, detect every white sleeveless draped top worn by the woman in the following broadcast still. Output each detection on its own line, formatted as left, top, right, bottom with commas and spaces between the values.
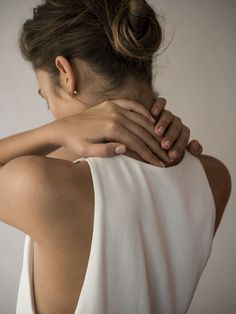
16, 151, 215, 314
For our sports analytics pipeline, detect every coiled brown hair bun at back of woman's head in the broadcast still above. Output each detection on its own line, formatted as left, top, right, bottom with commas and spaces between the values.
112, 0, 162, 60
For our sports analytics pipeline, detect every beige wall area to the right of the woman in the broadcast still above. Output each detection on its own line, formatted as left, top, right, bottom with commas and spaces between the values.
151, 0, 236, 314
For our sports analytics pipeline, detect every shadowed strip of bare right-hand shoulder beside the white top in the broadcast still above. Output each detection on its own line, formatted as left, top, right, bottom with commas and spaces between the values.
198, 155, 232, 235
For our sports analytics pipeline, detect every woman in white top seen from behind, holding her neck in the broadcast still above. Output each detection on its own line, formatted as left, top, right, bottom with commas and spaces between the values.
0, 0, 231, 314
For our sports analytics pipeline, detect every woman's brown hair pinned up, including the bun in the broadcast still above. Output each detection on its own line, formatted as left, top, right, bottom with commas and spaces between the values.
19, 0, 162, 90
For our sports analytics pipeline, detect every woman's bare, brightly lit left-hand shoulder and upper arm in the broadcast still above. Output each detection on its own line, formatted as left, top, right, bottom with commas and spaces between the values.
0, 156, 82, 241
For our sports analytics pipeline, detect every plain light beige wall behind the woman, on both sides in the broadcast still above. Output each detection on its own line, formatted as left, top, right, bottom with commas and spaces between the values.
0, 0, 236, 314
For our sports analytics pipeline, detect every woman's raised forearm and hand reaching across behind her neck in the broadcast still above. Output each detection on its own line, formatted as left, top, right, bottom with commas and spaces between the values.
0, 101, 163, 165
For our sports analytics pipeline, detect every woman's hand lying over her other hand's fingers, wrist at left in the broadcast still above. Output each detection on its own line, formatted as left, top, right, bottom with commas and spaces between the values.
53, 99, 203, 166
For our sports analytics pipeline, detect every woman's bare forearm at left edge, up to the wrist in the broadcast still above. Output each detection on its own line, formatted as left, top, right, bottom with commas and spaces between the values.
0, 123, 61, 165
